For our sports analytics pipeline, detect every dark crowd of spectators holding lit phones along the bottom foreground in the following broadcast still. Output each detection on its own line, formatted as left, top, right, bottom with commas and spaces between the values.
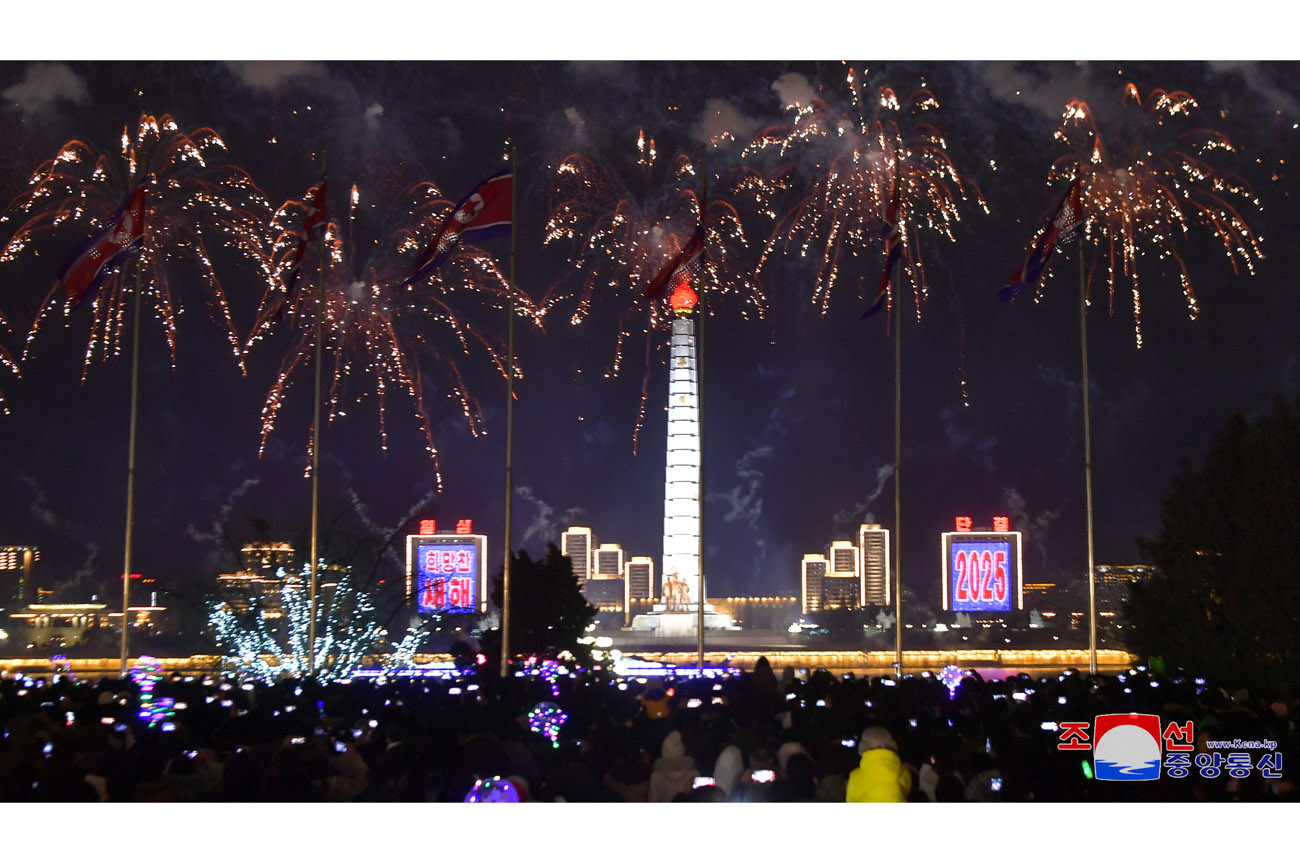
0, 659, 1300, 802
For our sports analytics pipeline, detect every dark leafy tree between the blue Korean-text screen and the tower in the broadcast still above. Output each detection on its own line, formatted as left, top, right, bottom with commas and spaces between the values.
482, 544, 597, 662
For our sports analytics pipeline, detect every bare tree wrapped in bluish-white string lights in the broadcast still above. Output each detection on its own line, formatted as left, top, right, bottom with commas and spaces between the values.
208, 567, 387, 683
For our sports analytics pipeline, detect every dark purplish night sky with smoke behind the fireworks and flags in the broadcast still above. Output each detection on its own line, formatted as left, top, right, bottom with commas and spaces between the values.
0, 25, 1300, 621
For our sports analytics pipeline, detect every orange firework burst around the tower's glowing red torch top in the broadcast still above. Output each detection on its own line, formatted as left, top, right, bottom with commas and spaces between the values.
541, 130, 766, 451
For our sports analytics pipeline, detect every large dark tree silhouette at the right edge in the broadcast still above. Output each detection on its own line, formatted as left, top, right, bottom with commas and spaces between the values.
1125, 399, 1300, 684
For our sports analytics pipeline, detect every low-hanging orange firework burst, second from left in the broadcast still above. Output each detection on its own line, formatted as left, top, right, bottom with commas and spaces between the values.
248, 182, 540, 489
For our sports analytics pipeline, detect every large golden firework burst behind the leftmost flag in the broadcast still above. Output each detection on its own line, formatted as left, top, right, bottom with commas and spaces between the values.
0, 114, 272, 381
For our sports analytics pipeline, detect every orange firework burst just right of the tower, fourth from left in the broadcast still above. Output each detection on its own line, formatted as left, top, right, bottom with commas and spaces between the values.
736, 64, 988, 319
